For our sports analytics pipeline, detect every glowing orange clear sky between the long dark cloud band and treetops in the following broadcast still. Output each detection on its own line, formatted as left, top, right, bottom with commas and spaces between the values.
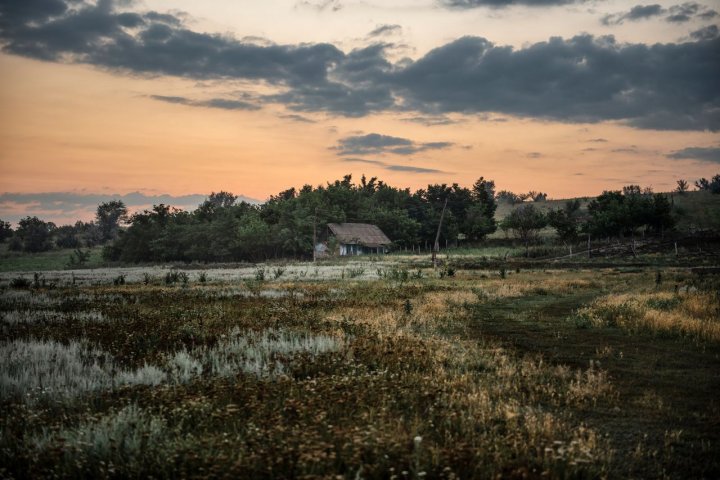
0, 2, 719, 223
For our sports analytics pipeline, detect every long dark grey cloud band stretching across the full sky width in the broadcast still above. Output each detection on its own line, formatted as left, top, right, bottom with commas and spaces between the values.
0, 0, 720, 131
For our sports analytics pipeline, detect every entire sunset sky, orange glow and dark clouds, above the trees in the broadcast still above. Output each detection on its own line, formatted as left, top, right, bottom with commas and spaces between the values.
0, 0, 720, 224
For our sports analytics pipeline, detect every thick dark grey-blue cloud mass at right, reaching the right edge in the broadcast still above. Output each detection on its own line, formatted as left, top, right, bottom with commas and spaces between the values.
394, 35, 720, 131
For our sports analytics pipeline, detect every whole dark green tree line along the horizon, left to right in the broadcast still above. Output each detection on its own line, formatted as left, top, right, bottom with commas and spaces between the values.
0, 175, 720, 262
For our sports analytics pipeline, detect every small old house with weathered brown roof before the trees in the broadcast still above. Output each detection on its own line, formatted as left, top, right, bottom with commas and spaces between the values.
316, 223, 392, 256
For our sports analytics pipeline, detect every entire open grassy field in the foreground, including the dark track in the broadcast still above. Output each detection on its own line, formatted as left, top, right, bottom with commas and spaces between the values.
0, 262, 720, 479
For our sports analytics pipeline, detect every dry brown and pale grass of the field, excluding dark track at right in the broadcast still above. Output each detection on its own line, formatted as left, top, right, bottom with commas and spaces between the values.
0, 267, 712, 478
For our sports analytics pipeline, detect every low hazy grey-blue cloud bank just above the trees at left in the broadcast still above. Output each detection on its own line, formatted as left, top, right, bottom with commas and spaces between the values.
0, 192, 260, 223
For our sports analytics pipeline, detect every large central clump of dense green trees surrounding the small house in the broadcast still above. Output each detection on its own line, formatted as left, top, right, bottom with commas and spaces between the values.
103, 175, 496, 262
